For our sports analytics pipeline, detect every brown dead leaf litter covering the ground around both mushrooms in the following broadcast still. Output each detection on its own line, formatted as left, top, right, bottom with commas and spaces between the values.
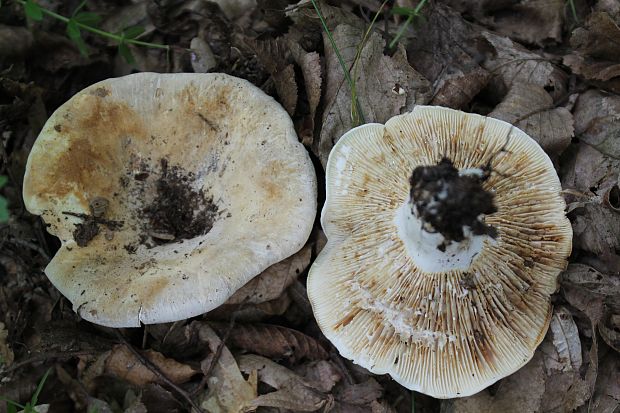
0, 0, 620, 413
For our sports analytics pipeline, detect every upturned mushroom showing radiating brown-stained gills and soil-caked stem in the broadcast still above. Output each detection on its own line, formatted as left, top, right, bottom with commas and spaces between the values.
308, 106, 572, 398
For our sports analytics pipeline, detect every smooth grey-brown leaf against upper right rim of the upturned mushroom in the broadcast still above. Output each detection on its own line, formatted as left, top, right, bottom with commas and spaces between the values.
489, 83, 574, 156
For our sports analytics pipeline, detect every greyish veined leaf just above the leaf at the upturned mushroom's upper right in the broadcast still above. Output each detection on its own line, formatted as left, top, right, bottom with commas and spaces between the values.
482, 31, 567, 99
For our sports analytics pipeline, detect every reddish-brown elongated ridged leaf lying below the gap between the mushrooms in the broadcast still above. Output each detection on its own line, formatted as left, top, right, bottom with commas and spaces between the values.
212, 323, 329, 363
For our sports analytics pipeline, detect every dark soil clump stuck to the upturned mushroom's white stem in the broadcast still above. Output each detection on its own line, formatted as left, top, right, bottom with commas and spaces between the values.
409, 158, 497, 251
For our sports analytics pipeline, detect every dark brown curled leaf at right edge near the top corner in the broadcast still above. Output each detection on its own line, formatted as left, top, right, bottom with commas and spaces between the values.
564, 12, 620, 93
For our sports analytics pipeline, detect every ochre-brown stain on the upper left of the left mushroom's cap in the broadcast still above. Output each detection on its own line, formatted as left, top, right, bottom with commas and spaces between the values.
31, 93, 148, 208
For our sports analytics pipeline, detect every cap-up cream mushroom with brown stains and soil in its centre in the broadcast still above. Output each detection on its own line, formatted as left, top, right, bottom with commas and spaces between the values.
23, 73, 316, 327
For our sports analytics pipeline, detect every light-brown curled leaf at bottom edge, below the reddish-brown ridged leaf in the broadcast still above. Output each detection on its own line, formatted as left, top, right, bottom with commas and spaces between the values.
239, 355, 331, 412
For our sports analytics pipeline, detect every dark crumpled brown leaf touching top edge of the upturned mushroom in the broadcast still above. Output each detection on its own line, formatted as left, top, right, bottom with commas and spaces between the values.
407, 4, 491, 109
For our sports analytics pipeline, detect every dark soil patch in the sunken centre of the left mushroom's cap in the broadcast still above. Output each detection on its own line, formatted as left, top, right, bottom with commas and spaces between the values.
143, 159, 218, 245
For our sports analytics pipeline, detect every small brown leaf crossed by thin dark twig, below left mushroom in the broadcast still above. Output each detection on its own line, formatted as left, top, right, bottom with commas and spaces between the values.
105, 344, 198, 386
